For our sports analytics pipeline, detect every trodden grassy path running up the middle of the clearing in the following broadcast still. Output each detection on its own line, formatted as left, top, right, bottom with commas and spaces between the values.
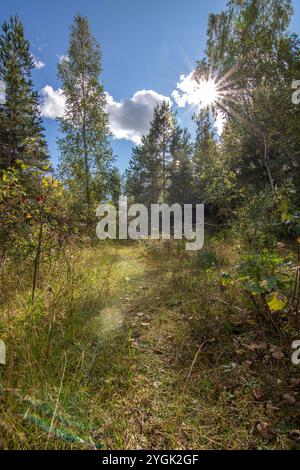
84, 247, 222, 448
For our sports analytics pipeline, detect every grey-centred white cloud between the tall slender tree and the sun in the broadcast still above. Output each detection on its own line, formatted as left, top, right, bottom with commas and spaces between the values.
107, 90, 171, 144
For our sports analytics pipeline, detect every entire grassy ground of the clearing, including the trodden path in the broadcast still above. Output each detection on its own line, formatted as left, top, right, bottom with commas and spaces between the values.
0, 242, 299, 449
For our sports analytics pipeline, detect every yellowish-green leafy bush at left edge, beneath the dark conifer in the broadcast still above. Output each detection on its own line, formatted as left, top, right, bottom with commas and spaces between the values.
0, 169, 72, 282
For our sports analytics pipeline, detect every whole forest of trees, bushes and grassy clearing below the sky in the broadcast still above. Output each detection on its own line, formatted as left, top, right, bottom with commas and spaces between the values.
0, 0, 300, 450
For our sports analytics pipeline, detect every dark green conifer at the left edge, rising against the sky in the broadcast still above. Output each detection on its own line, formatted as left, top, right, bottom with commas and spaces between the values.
0, 16, 49, 176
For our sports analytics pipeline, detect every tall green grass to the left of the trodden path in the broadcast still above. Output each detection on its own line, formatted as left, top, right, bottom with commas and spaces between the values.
0, 243, 142, 449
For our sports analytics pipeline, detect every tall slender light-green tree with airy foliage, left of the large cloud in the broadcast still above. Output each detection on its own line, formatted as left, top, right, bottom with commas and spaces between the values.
58, 15, 113, 220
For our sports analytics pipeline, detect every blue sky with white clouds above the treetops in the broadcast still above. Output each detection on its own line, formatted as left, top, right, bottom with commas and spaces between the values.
0, 0, 300, 170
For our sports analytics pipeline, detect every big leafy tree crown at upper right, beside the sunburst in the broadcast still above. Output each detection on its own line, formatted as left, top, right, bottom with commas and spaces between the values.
202, 0, 300, 197
